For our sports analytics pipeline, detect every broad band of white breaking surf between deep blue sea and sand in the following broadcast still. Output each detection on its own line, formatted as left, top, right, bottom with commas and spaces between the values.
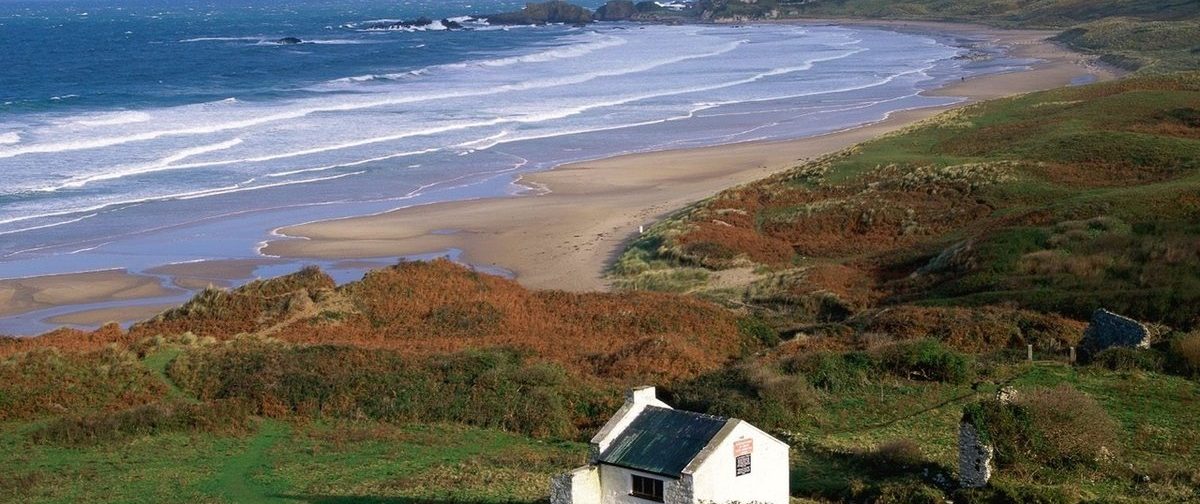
0, 26, 974, 252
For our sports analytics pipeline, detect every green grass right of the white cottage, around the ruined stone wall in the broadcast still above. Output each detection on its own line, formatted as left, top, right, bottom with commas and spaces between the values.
781, 362, 1200, 502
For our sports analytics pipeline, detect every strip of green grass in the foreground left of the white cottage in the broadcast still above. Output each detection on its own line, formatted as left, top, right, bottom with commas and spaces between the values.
0, 420, 587, 503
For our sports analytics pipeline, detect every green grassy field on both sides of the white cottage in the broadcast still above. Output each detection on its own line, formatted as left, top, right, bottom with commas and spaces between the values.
0, 328, 1200, 503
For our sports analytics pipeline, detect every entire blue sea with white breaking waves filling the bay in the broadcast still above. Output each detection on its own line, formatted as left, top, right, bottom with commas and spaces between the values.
0, 0, 1027, 330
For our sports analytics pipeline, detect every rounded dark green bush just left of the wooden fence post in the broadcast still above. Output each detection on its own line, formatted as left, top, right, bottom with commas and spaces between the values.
878, 340, 973, 383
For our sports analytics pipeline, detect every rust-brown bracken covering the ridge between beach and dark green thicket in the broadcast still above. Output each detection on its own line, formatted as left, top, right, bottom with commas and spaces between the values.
0, 260, 754, 383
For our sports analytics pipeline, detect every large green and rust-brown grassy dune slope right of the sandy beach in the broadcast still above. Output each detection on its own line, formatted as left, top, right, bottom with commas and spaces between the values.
614, 73, 1200, 331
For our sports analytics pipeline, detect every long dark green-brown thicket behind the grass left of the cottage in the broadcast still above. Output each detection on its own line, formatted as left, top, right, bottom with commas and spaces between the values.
167, 338, 597, 437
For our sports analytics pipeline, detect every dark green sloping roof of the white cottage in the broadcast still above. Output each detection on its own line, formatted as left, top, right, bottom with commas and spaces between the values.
599, 406, 728, 478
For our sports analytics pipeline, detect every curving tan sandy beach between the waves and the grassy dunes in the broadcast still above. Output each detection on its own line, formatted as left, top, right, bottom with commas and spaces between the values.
0, 19, 1122, 333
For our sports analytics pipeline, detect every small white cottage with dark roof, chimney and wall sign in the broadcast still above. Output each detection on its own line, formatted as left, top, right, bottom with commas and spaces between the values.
550, 386, 788, 504
